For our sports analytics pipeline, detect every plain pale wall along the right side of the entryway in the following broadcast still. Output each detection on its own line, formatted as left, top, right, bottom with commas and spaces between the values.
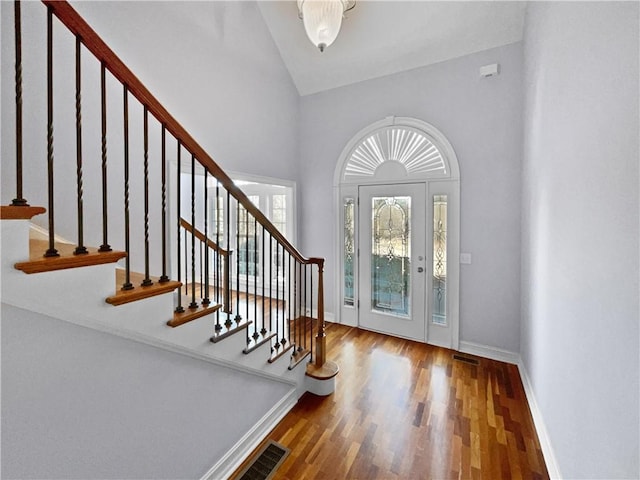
521, 2, 640, 478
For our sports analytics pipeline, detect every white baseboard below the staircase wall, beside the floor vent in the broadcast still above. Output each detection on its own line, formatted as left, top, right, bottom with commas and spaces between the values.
201, 389, 298, 480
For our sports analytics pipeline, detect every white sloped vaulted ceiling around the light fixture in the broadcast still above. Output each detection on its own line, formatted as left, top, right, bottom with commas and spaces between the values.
258, 0, 526, 95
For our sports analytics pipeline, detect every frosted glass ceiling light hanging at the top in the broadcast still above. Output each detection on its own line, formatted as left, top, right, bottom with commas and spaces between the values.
298, 0, 356, 52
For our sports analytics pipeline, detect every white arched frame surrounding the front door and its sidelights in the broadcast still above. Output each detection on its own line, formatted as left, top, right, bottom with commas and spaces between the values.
334, 117, 460, 350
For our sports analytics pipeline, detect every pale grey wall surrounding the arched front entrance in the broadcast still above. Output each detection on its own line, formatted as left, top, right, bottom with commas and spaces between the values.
298, 44, 522, 352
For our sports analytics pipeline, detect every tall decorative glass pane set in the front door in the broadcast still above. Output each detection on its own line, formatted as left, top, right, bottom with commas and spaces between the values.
371, 197, 411, 317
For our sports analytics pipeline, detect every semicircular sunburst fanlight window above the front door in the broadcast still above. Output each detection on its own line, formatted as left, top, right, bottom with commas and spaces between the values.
344, 127, 448, 179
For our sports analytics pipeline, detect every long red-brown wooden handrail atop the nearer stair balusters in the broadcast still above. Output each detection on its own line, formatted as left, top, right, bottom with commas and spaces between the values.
42, 0, 322, 265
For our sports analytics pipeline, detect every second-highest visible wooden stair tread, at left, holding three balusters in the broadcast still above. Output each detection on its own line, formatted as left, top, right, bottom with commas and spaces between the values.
15, 238, 127, 273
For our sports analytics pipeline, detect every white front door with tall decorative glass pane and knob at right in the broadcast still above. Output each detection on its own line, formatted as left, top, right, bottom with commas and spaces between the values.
358, 183, 428, 342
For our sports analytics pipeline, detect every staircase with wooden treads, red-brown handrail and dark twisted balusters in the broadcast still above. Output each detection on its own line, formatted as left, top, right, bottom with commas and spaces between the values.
0, 1, 338, 476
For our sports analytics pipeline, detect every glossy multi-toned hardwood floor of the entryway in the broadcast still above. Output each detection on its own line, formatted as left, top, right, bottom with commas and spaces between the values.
232, 324, 549, 480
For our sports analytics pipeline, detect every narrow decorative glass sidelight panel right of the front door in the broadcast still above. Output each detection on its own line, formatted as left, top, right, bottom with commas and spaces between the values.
431, 195, 447, 325
